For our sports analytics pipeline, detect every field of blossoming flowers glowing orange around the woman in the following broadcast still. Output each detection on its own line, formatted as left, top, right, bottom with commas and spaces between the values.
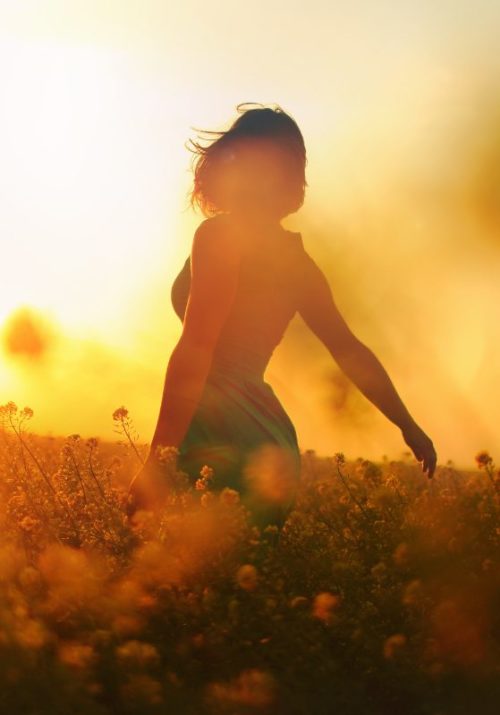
0, 402, 500, 715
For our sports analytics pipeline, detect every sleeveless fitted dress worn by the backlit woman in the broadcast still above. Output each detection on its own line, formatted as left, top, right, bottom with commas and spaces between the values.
171, 230, 306, 528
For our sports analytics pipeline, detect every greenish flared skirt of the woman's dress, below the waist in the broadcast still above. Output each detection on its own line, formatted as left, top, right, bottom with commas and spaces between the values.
177, 370, 301, 529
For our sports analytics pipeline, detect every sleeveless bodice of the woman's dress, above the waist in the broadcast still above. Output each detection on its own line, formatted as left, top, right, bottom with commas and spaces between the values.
171, 230, 306, 381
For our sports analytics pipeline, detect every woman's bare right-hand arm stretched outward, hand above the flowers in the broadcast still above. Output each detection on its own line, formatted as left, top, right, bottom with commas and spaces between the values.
298, 251, 436, 476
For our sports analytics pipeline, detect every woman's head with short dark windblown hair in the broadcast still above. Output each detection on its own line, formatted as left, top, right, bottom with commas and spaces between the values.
186, 103, 307, 220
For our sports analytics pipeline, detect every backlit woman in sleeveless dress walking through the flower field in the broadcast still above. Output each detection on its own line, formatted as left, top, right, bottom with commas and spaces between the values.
129, 105, 436, 527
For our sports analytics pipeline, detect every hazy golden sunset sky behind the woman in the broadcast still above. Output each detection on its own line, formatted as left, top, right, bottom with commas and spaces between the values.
0, 0, 500, 468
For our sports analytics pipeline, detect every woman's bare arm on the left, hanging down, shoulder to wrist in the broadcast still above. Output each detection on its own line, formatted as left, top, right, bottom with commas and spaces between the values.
150, 219, 239, 453
